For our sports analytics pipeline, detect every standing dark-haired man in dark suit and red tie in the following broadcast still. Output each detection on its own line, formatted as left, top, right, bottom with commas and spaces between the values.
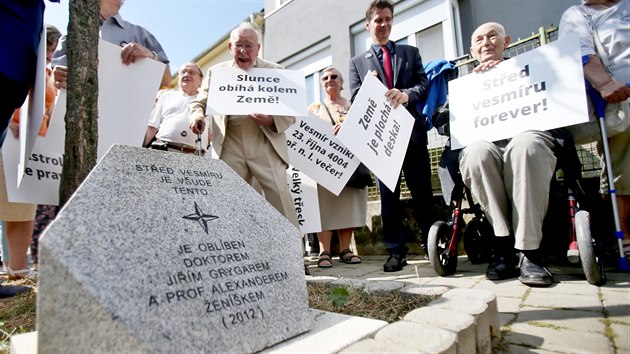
350, 0, 435, 272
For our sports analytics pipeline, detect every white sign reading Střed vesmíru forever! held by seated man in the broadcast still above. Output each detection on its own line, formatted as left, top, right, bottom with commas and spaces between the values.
449, 37, 588, 150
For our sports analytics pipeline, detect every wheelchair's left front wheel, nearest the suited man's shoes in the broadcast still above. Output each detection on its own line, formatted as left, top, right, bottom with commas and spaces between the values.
427, 221, 457, 276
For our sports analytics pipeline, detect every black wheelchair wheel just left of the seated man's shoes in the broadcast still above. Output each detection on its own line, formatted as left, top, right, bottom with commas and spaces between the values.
464, 218, 494, 264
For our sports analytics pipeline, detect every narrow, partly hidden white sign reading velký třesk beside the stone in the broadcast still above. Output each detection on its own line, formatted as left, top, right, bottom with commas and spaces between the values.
287, 166, 322, 234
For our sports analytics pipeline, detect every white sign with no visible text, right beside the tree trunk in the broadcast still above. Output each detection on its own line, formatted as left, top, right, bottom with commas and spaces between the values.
97, 40, 165, 160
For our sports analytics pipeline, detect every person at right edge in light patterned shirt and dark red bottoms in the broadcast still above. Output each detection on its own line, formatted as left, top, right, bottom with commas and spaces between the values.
560, 0, 630, 257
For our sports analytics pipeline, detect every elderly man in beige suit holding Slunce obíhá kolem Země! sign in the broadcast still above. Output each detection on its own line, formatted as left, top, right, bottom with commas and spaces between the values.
189, 24, 298, 227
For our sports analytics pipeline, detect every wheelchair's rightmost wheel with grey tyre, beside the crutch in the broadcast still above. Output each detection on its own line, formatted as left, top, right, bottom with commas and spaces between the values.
575, 210, 603, 285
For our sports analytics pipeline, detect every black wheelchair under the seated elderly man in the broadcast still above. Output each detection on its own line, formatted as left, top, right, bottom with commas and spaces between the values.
427, 105, 606, 285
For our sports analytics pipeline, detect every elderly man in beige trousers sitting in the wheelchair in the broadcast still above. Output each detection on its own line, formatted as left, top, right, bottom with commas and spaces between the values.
440, 22, 579, 286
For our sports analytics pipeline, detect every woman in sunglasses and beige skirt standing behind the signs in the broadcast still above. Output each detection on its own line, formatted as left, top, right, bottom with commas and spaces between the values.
308, 67, 367, 268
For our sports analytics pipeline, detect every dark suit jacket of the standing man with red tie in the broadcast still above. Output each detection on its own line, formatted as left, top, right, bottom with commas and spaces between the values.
350, 44, 429, 144
